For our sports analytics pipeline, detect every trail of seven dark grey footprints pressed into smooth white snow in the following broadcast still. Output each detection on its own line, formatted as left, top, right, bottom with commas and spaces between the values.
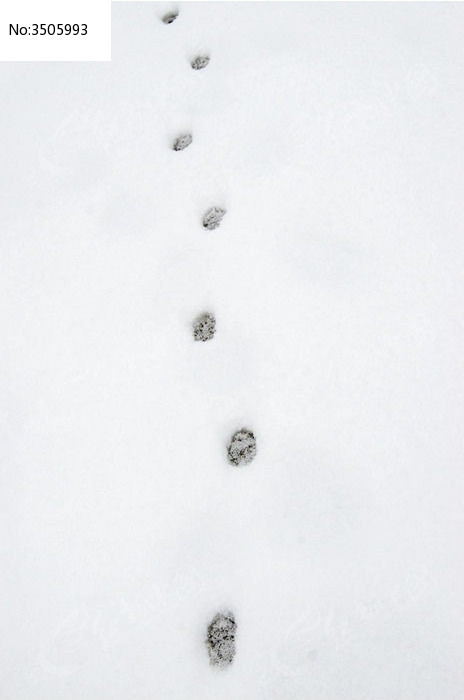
162, 11, 256, 668
